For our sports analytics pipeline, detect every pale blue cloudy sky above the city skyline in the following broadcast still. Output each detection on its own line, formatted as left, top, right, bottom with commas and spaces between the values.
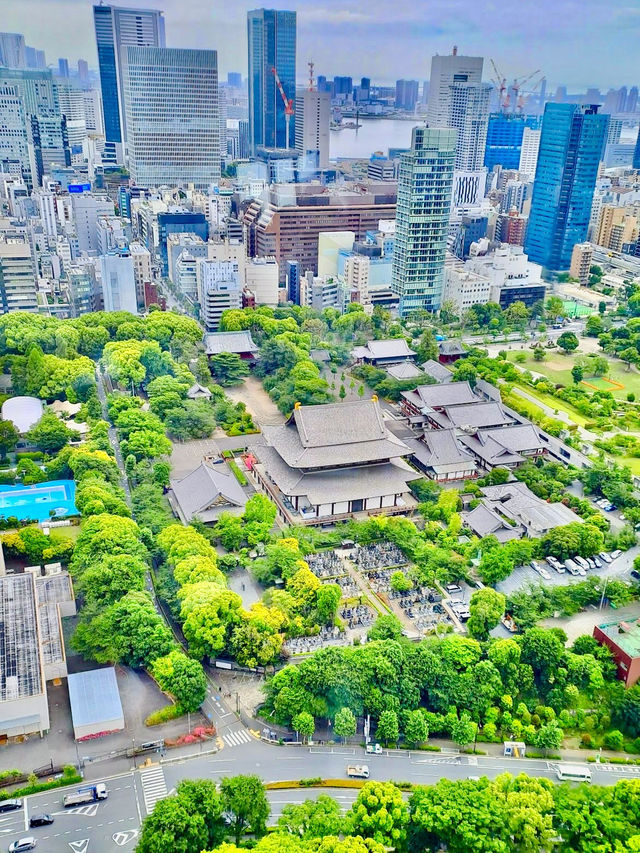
0, 0, 640, 91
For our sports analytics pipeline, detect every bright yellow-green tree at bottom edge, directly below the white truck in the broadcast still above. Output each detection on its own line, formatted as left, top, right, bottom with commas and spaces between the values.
346, 782, 409, 850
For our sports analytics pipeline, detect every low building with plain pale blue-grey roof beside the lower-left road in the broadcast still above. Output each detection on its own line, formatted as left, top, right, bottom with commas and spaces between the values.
68, 666, 124, 740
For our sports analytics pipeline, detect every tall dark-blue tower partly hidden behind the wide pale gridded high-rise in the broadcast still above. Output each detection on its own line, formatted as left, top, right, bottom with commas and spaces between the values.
93, 3, 165, 162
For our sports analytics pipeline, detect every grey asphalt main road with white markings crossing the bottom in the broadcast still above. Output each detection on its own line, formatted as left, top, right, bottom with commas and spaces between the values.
0, 739, 640, 853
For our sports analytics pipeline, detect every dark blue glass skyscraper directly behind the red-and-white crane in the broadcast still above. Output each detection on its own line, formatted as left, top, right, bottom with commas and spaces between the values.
247, 9, 296, 154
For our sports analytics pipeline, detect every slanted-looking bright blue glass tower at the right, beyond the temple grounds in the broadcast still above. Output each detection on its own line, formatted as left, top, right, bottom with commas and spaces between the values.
525, 103, 609, 270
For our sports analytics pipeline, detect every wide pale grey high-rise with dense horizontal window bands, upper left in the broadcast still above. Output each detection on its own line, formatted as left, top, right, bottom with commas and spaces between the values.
122, 47, 220, 187
